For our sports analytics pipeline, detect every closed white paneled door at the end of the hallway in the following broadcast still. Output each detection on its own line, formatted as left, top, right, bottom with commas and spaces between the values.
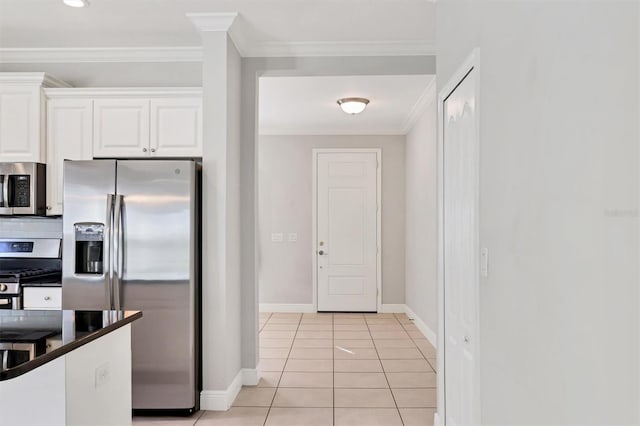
315, 152, 379, 312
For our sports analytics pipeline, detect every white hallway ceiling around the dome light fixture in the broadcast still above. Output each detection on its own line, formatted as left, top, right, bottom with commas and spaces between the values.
259, 75, 435, 135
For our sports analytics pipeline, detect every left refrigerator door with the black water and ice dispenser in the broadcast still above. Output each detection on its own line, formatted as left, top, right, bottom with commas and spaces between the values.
62, 160, 116, 309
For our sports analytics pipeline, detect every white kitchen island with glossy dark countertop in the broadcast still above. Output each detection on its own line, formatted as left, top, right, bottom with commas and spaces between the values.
0, 310, 142, 426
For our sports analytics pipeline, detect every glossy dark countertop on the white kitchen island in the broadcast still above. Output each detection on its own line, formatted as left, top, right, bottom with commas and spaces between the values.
0, 310, 142, 381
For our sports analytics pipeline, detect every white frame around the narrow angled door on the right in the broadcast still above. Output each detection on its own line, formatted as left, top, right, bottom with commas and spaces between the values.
436, 48, 482, 426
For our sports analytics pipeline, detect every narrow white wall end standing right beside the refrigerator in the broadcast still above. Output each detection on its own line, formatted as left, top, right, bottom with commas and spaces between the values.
201, 31, 242, 409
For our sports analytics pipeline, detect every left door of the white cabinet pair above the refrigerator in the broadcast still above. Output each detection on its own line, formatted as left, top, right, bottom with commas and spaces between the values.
93, 98, 149, 158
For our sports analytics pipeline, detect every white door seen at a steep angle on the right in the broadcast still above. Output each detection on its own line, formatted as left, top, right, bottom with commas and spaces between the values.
442, 65, 479, 426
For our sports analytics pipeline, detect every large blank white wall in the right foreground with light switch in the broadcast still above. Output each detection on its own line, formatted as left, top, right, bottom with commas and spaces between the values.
437, 0, 640, 425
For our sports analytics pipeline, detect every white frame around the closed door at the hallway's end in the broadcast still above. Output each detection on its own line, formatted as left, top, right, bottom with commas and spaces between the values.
311, 148, 382, 312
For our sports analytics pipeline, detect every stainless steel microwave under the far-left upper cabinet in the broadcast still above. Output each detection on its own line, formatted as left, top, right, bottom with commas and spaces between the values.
0, 163, 47, 216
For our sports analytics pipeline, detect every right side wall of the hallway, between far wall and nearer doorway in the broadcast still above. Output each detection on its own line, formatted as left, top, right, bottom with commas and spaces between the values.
405, 81, 438, 333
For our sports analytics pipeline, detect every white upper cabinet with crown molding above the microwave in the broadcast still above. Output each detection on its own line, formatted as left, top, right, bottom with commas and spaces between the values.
0, 72, 68, 162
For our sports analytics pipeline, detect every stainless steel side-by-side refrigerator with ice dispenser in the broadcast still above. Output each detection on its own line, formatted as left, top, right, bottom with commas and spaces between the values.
62, 160, 201, 412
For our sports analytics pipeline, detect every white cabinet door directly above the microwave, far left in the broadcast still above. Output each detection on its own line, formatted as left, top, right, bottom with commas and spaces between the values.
0, 85, 44, 162
